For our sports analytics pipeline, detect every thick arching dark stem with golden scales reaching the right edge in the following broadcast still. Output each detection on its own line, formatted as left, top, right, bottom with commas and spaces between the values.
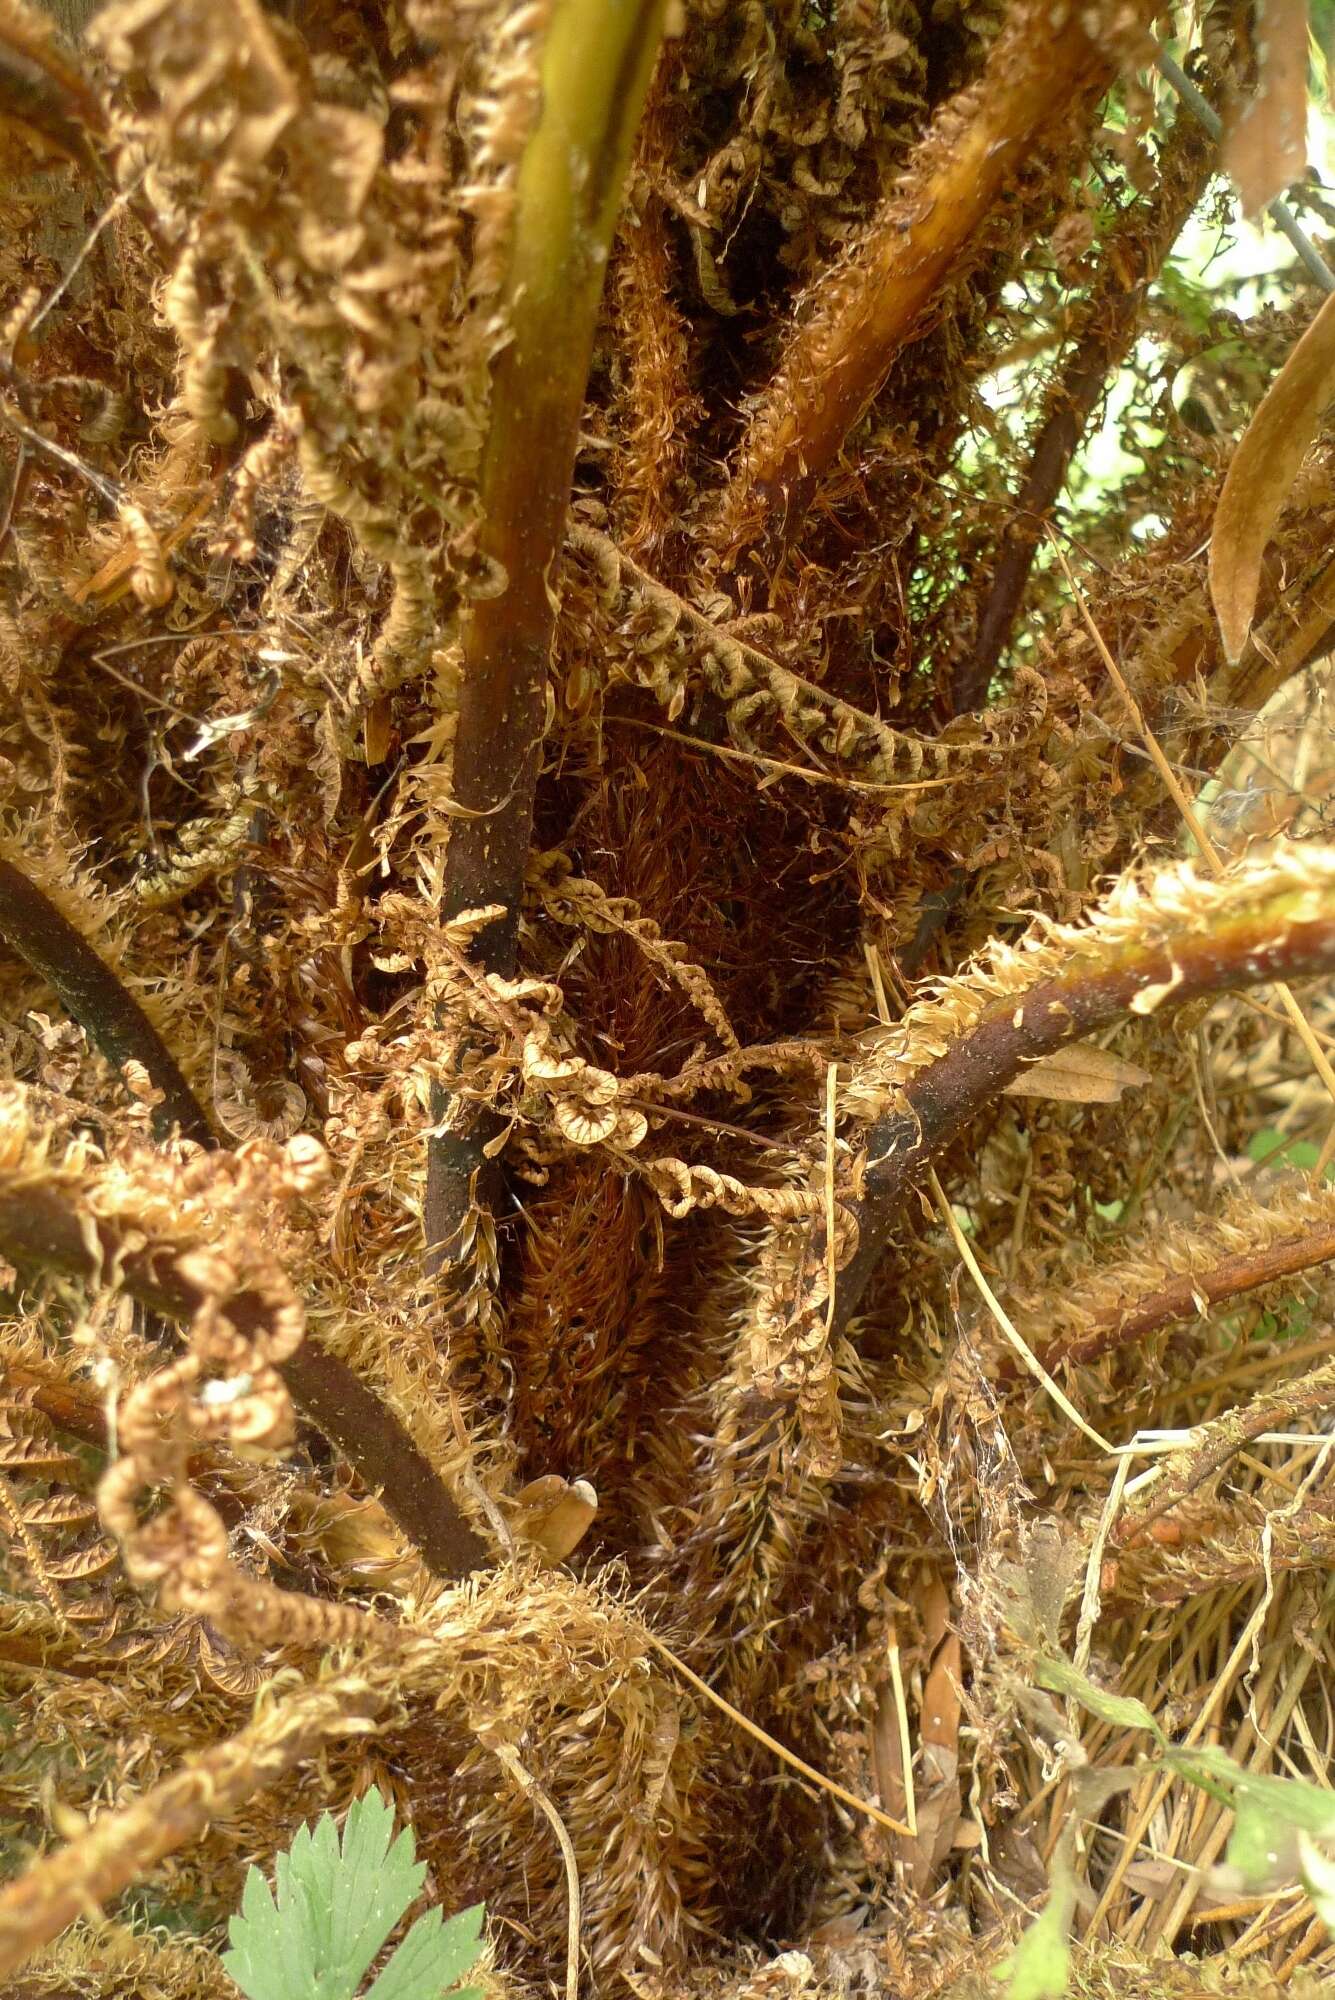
831, 874, 1335, 1334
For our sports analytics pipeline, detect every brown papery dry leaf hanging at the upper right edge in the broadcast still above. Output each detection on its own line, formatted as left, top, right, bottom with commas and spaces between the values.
1209, 296, 1335, 660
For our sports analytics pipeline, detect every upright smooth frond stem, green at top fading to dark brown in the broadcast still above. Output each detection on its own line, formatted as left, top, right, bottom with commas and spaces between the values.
426, 0, 664, 1268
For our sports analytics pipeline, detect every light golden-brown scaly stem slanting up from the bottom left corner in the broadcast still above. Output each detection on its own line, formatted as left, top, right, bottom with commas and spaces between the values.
0, 1674, 384, 1978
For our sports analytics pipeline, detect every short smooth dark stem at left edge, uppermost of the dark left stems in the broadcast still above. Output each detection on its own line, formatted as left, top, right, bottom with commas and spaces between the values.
0, 856, 218, 1146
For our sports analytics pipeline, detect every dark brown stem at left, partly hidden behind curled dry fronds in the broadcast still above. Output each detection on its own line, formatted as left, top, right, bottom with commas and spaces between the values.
0, 1182, 488, 1576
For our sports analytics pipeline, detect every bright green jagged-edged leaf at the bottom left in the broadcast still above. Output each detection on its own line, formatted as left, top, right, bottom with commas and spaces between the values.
222, 1790, 484, 2000
